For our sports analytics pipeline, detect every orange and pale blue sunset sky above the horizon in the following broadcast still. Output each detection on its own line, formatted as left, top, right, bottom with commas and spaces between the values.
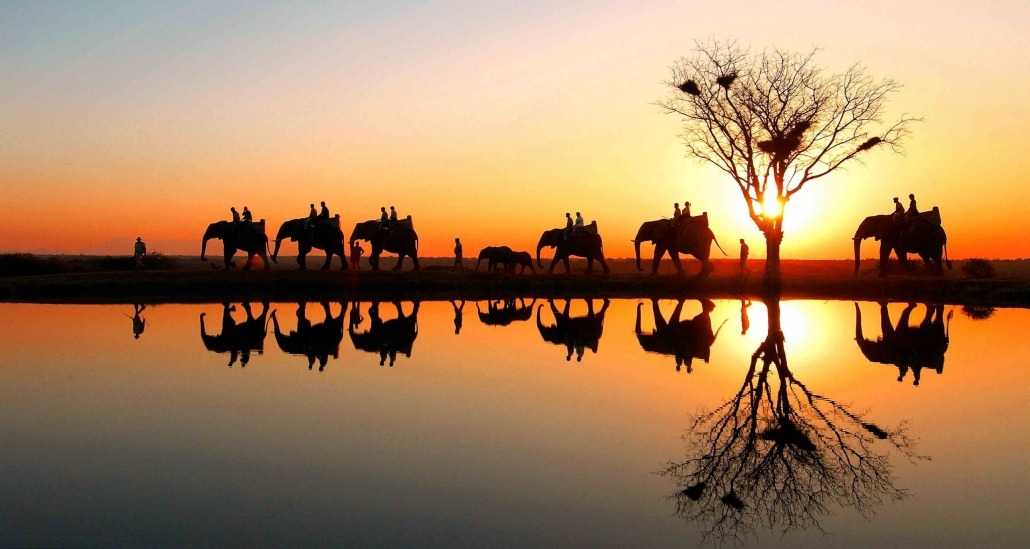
0, 0, 1030, 259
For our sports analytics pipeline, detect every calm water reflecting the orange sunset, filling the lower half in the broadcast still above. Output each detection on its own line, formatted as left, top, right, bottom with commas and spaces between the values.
0, 300, 1030, 547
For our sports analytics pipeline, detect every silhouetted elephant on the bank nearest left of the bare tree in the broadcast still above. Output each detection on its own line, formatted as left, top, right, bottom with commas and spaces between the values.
633, 212, 726, 275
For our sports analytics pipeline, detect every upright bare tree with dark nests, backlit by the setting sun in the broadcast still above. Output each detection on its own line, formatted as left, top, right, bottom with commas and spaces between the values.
657, 41, 916, 278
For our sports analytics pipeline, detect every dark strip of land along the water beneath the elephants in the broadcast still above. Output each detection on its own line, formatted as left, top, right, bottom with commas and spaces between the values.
0, 266, 1030, 308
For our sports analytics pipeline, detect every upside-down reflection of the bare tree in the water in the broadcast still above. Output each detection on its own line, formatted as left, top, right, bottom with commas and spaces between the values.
661, 298, 931, 542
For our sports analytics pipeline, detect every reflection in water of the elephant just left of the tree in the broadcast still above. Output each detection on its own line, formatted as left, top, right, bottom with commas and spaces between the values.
633, 299, 722, 374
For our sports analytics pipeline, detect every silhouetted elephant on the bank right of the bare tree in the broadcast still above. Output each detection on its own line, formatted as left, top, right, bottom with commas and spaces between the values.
854, 206, 952, 276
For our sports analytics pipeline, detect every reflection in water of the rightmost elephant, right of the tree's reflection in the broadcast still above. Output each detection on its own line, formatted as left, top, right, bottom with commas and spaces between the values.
855, 303, 951, 385
